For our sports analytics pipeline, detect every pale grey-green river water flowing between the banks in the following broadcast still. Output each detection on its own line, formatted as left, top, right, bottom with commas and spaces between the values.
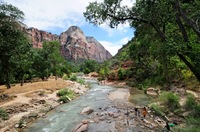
28, 81, 148, 132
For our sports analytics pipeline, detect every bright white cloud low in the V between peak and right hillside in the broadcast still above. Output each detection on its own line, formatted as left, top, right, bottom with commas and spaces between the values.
99, 37, 130, 56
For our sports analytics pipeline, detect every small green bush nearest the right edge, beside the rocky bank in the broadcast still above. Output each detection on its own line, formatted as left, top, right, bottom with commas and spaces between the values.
185, 94, 197, 110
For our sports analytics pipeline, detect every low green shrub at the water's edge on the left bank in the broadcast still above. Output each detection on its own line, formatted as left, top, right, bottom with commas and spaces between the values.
57, 88, 76, 103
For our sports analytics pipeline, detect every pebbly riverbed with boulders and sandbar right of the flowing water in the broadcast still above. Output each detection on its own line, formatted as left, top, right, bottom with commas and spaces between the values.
73, 88, 165, 132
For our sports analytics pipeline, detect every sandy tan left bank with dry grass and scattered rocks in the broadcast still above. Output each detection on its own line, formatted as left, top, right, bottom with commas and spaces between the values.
0, 78, 88, 132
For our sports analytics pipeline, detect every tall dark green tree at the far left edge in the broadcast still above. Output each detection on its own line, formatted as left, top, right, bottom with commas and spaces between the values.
0, 2, 29, 88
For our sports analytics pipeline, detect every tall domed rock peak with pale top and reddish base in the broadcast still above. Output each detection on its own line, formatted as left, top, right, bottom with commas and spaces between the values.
60, 26, 112, 62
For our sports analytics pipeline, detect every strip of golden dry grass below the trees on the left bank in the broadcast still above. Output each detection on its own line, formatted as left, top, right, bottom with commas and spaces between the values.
0, 79, 72, 94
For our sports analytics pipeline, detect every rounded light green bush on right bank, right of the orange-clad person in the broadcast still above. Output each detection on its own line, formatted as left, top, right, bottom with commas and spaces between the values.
159, 92, 180, 110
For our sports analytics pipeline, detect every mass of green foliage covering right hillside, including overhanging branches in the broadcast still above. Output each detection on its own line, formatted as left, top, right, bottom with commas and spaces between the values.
84, 0, 200, 84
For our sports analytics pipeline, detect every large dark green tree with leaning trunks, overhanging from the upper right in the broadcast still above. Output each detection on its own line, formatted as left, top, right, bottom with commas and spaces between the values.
84, 0, 200, 81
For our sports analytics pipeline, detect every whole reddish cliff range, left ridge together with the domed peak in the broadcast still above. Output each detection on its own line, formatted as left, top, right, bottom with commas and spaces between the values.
26, 26, 112, 62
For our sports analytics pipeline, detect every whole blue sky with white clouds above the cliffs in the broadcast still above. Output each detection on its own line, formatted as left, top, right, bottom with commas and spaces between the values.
3, 0, 135, 55
